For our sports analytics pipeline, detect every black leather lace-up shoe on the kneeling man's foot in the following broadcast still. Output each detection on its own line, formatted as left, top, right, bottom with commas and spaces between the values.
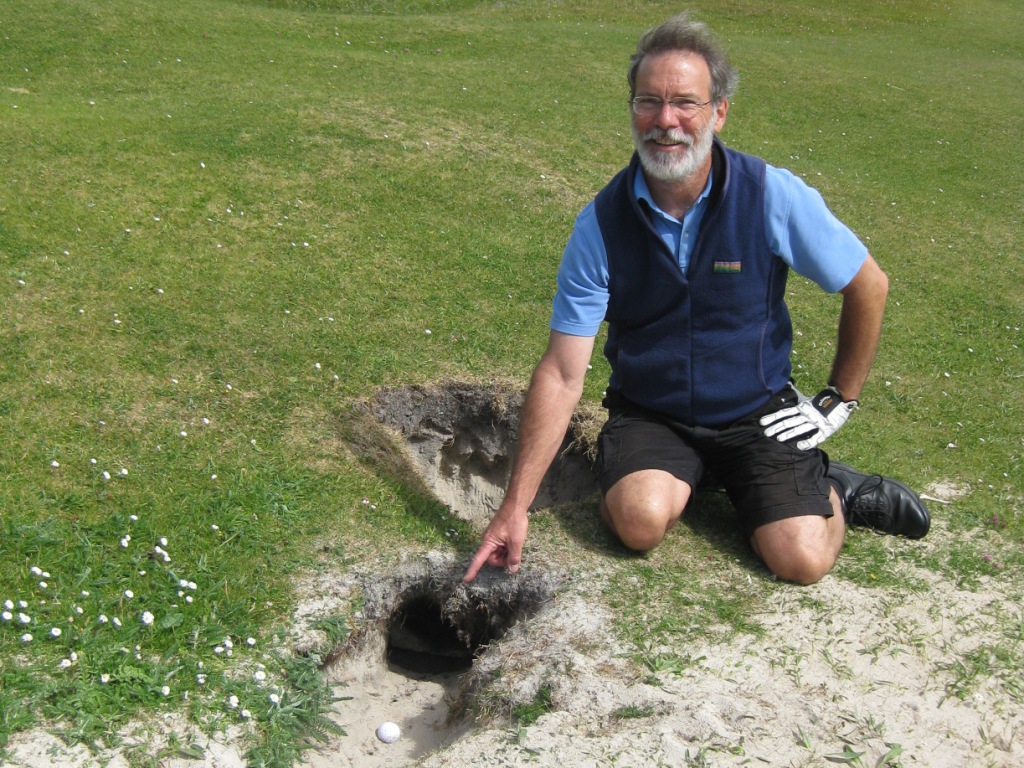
828, 462, 931, 539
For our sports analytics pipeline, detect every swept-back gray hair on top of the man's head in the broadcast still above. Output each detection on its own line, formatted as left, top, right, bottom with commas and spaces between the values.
629, 12, 739, 104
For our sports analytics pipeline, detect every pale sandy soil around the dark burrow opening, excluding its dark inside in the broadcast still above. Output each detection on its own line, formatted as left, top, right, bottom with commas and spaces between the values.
4, 495, 1024, 768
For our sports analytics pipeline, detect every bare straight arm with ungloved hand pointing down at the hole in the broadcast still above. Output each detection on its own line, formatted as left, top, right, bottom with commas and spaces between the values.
465, 331, 594, 582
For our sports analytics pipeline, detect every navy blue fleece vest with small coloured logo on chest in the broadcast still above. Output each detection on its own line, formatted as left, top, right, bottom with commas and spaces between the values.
595, 140, 793, 427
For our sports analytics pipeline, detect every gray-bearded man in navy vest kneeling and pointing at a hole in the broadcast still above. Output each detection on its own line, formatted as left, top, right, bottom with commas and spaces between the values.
465, 9, 929, 584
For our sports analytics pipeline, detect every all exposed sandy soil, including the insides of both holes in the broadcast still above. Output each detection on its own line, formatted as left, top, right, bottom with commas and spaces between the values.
4, 387, 1024, 768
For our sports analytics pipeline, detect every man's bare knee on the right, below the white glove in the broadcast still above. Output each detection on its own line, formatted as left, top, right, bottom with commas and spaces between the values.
751, 488, 846, 584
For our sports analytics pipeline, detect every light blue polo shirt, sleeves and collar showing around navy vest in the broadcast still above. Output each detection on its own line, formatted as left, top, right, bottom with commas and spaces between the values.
551, 165, 867, 336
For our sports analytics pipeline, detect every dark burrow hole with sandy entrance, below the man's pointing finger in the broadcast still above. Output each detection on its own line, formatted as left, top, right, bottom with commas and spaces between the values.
324, 553, 561, 768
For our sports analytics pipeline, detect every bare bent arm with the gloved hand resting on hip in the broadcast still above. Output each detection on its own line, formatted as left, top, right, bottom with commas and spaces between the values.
828, 255, 889, 400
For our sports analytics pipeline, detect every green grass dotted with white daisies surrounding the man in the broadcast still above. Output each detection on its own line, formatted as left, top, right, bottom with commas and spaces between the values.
0, 0, 1024, 765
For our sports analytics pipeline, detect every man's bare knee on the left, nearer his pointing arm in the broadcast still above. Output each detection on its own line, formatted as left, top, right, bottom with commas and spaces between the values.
601, 469, 691, 552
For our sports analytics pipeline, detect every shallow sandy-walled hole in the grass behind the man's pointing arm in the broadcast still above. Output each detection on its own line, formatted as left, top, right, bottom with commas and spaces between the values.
374, 384, 600, 525
